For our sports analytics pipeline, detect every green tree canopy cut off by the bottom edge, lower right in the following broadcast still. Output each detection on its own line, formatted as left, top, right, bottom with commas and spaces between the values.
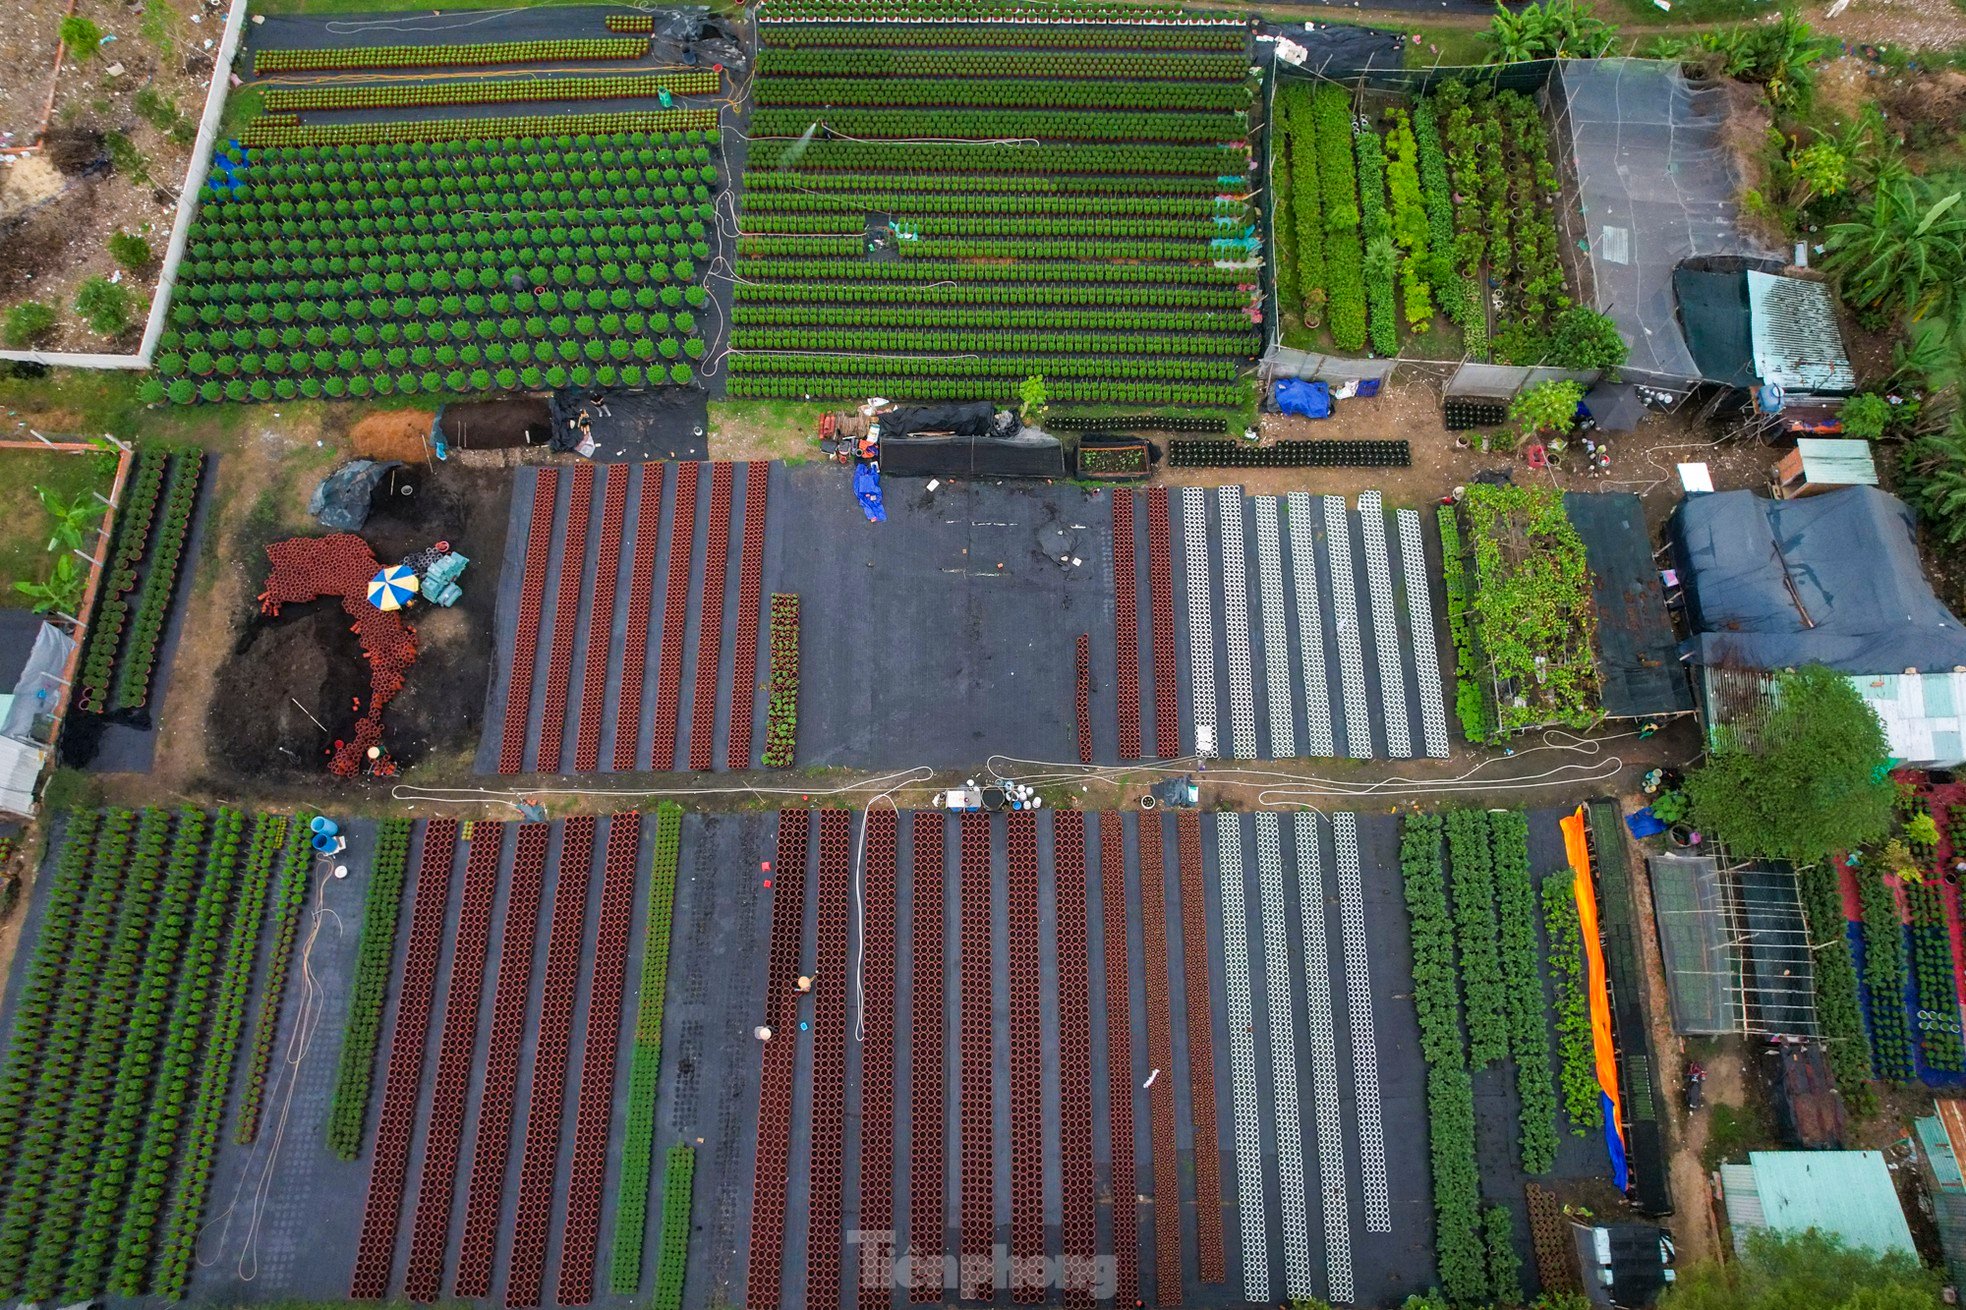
1659, 1229, 1944, 1310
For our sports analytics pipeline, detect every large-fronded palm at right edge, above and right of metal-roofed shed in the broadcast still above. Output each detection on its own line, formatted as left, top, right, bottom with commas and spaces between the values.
1822, 179, 1966, 321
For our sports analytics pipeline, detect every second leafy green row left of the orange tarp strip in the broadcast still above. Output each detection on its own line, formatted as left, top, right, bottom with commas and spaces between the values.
1488, 810, 1557, 1174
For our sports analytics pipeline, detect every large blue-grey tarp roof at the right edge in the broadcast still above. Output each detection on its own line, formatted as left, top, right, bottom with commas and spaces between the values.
1669, 486, 1966, 675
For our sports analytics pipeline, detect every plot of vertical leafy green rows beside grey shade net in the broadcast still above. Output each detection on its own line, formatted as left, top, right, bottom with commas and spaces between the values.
1270, 77, 1585, 366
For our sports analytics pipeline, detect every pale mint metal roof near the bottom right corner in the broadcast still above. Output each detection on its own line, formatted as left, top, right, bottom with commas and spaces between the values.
1728, 1151, 1917, 1257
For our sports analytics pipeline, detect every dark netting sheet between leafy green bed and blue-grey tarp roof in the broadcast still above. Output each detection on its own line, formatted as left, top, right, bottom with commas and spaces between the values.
1563, 492, 1693, 718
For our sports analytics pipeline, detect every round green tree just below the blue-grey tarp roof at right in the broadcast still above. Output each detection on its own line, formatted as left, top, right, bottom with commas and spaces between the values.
1687, 665, 1895, 863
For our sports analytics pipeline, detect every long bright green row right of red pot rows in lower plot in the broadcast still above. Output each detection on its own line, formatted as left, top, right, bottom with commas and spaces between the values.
607, 801, 682, 1296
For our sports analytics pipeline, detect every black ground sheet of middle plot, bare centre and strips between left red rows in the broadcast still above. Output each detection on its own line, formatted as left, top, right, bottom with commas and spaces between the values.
476, 464, 1119, 773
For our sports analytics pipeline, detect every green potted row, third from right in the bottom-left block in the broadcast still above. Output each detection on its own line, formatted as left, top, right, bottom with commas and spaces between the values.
108, 808, 246, 1296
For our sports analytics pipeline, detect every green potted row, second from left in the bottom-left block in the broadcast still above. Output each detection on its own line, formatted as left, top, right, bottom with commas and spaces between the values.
0, 810, 138, 1294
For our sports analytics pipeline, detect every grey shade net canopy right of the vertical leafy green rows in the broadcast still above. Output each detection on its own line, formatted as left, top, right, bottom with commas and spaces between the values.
1549, 59, 1773, 386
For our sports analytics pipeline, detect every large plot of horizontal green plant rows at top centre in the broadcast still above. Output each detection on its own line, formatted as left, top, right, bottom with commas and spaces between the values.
729, 10, 1260, 407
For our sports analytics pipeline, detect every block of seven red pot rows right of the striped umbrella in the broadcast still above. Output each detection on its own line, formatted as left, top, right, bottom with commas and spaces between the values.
478, 464, 774, 773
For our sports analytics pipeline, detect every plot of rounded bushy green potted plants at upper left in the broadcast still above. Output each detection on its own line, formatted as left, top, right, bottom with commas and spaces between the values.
145, 127, 722, 403
